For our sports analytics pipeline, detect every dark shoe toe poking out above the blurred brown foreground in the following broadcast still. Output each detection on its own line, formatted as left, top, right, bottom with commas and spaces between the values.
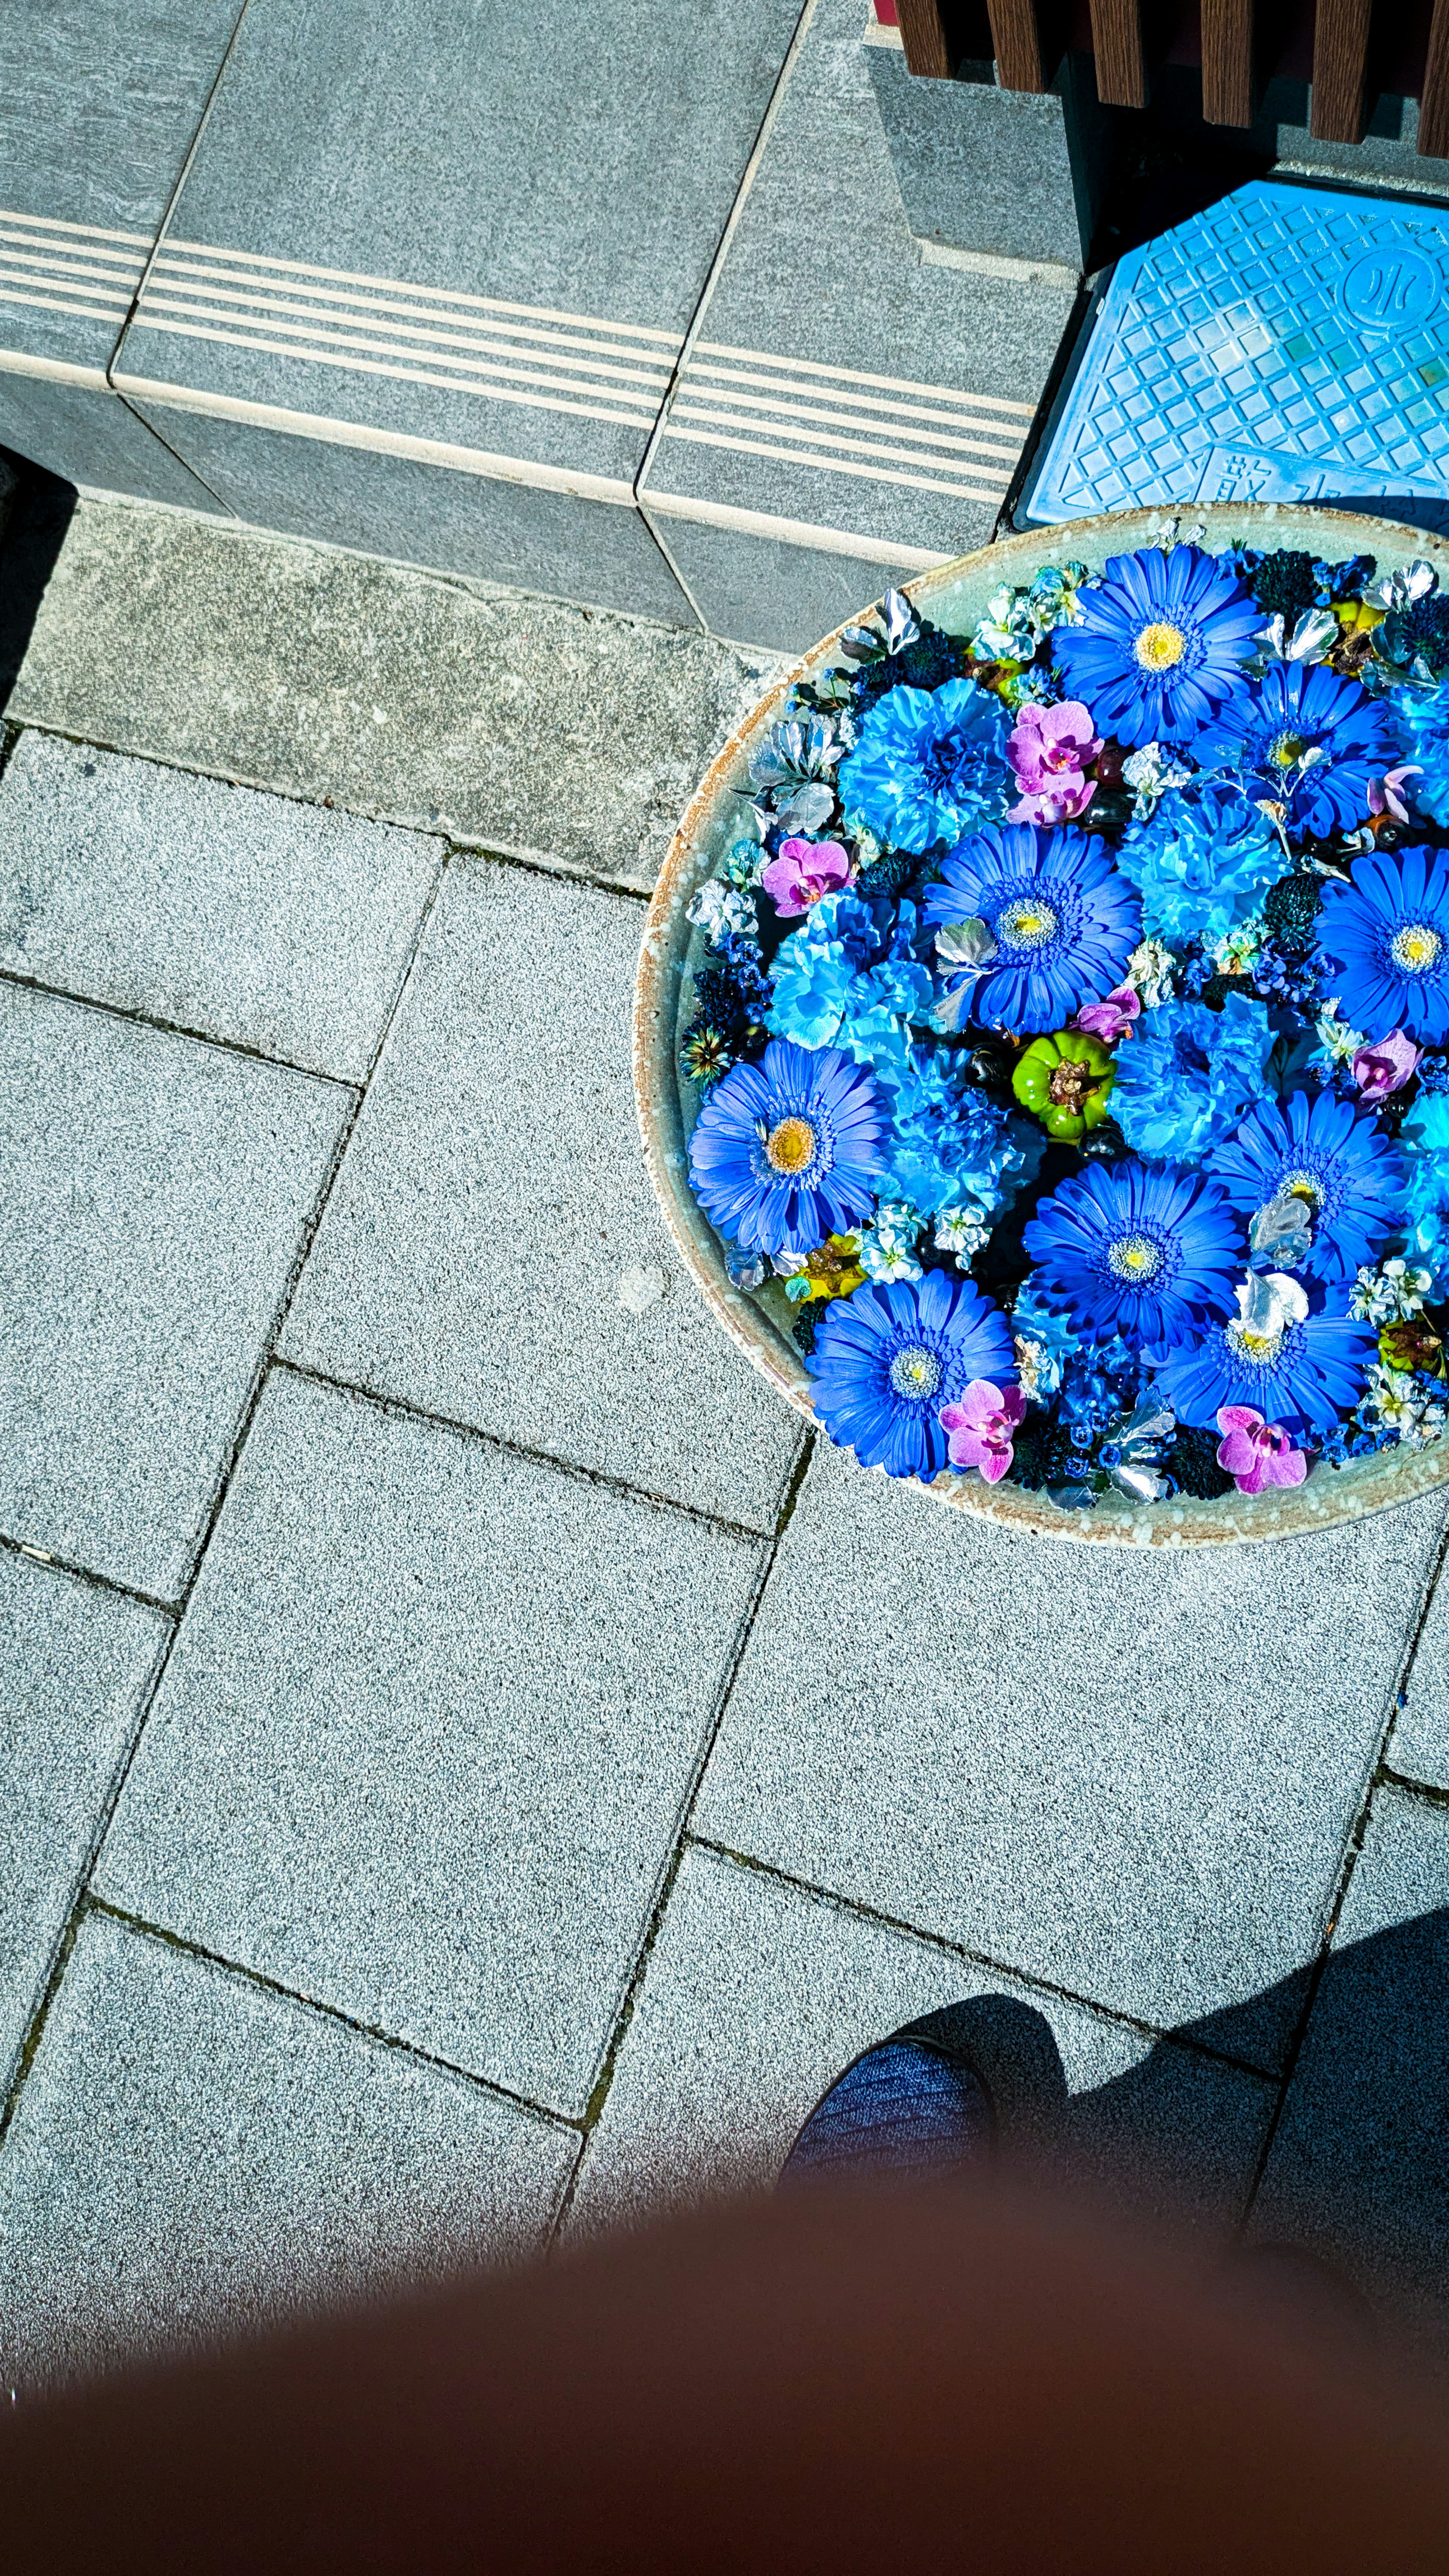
778, 2015, 995, 2184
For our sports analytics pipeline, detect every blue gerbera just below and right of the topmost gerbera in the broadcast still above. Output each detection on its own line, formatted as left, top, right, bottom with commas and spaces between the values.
1194, 662, 1400, 837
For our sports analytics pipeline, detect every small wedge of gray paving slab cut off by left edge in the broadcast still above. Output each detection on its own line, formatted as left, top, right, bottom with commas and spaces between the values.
0, 1548, 170, 2099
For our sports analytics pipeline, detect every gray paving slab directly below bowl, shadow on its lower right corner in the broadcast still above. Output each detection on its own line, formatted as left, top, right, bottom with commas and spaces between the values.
699, 1448, 1444, 2063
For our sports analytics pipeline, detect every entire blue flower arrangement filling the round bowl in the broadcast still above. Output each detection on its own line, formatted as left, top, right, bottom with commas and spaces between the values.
678, 531, 1449, 1512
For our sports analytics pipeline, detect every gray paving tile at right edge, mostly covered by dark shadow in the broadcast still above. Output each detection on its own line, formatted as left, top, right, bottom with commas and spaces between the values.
1253, 1788, 1449, 2373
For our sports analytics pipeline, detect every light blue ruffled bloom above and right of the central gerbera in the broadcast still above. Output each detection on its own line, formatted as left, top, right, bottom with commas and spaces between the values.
1117, 778, 1287, 948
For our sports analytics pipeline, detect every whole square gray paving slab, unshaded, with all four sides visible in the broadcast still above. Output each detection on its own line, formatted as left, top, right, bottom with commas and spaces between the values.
95, 1373, 758, 2112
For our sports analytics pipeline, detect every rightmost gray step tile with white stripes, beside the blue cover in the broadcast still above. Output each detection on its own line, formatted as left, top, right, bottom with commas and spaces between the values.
642, 0, 1072, 631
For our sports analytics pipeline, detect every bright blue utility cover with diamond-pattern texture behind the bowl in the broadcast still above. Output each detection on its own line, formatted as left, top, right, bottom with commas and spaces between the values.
1024, 180, 1449, 528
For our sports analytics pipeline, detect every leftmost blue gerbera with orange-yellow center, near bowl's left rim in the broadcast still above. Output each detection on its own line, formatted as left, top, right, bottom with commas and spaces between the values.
688, 1038, 882, 1255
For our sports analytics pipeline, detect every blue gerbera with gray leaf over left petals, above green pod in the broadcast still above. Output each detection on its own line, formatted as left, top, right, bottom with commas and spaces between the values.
897, 824, 1142, 1030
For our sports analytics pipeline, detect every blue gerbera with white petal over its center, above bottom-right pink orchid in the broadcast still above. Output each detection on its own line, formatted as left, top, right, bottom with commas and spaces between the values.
1152, 1283, 1377, 1432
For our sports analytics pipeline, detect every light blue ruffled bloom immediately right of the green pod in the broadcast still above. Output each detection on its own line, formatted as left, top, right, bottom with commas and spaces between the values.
1111, 992, 1274, 1162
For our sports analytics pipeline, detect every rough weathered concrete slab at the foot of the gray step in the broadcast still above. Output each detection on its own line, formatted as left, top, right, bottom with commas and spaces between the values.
5, 502, 774, 886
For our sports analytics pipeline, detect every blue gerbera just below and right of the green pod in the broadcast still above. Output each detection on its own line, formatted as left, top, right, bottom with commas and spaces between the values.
1024, 1162, 1243, 1345
